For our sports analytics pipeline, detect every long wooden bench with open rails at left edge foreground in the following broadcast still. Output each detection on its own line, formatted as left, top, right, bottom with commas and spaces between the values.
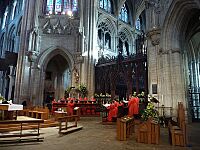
0, 119, 44, 143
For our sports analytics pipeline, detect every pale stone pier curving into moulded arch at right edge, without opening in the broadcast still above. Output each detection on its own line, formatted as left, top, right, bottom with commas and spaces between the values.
158, 0, 200, 120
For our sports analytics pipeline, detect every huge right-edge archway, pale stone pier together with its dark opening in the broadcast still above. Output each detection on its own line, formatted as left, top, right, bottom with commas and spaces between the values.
159, 0, 200, 121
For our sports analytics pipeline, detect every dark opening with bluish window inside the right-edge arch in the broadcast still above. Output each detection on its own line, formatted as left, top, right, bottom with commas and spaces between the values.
185, 9, 200, 121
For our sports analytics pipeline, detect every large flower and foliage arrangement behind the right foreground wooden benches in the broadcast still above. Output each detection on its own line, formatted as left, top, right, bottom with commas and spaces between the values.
142, 102, 159, 122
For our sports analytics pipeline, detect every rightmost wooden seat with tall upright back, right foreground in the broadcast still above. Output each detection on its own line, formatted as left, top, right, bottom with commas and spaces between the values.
168, 102, 187, 146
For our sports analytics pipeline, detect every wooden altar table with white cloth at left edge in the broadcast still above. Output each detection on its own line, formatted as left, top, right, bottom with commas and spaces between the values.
0, 104, 23, 120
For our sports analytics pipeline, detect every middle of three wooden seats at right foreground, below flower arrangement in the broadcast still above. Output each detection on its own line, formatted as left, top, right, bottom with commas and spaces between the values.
136, 119, 160, 144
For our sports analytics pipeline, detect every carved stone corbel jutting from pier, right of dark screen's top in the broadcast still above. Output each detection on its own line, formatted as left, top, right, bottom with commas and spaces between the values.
147, 28, 160, 46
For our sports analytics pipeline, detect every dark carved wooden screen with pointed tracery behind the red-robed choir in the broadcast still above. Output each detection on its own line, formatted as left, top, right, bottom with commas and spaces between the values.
95, 35, 148, 100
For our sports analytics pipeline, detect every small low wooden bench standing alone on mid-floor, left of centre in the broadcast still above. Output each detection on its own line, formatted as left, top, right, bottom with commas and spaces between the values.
58, 115, 83, 134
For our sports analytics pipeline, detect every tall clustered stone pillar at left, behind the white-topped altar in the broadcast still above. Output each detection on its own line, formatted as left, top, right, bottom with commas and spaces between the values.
14, 0, 36, 103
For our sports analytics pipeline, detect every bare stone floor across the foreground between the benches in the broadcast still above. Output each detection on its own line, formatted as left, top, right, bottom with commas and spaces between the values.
0, 117, 200, 150
